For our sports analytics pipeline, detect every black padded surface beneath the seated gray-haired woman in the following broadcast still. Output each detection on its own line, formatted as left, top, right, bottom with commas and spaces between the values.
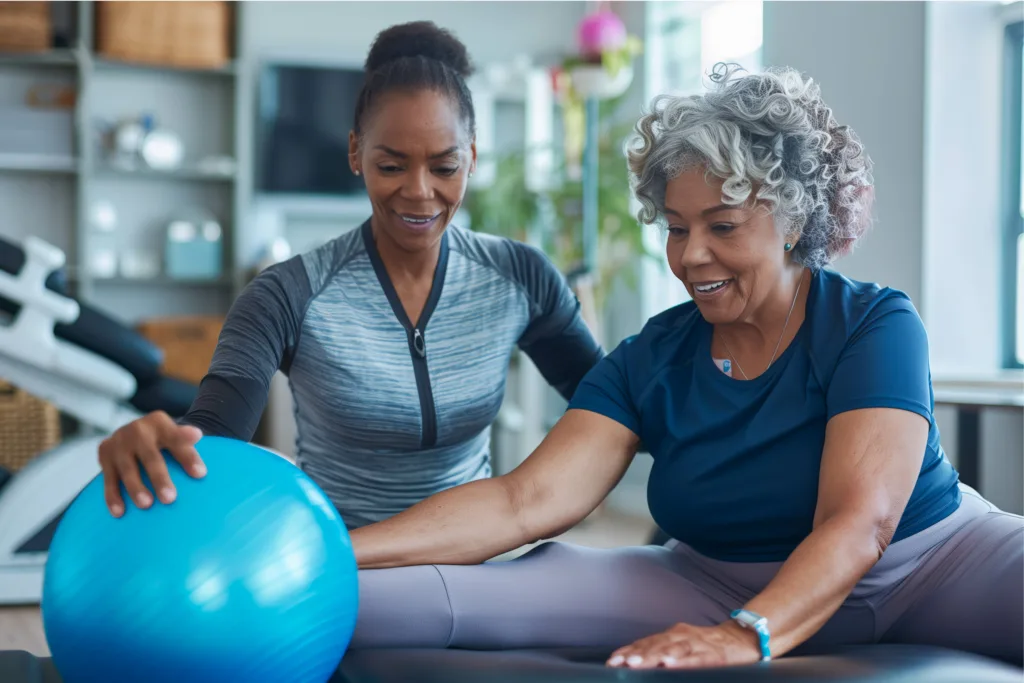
0, 645, 1024, 683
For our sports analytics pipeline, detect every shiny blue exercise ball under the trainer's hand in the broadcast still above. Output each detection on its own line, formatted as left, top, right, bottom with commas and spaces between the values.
42, 436, 358, 683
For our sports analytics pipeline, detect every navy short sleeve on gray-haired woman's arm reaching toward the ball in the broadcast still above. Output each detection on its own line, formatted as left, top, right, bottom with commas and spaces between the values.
568, 337, 640, 435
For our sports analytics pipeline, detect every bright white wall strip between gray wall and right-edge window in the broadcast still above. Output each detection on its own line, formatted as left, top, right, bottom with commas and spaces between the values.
924, 2, 1004, 374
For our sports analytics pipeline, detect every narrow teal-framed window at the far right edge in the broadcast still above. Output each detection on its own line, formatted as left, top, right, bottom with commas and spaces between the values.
1002, 22, 1024, 368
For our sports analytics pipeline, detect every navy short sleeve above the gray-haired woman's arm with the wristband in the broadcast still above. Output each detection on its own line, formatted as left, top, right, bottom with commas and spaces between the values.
826, 296, 932, 420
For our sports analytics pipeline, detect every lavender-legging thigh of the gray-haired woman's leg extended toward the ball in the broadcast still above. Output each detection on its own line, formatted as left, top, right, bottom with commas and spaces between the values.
439, 543, 728, 649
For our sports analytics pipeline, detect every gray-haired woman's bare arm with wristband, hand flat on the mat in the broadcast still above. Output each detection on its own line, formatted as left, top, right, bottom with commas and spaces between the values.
610, 409, 928, 668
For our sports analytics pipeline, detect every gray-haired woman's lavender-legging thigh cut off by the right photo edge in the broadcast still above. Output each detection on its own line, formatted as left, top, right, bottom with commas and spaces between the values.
882, 511, 1024, 665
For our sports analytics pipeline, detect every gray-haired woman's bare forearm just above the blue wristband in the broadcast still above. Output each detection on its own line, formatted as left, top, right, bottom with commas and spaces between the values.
745, 516, 881, 655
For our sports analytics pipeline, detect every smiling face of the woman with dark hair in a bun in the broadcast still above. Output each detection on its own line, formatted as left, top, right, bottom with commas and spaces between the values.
349, 90, 476, 252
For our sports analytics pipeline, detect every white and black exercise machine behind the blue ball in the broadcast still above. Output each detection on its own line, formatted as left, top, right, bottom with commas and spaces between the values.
0, 237, 197, 604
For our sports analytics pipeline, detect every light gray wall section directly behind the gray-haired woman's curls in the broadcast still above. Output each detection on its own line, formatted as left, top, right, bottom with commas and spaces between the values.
764, 2, 926, 308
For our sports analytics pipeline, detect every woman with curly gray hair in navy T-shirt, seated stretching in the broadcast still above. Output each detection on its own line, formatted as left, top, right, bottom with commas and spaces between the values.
339, 69, 1024, 668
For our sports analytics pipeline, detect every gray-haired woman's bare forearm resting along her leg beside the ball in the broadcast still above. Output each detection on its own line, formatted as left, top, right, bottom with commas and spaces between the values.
351, 477, 532, 569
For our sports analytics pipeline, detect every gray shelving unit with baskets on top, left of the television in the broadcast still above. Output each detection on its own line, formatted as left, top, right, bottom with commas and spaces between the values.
0, 1, 245, 325
